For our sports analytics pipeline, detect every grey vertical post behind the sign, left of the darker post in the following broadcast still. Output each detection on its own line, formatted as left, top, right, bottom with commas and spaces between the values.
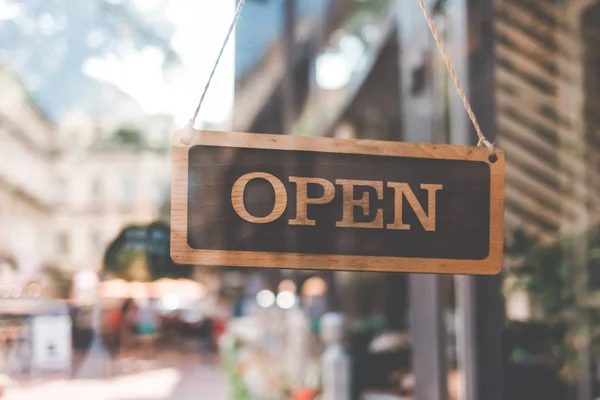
397, 0, 448, 400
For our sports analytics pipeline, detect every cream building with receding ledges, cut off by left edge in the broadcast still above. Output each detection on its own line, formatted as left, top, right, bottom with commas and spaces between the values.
0, 65, 53, 269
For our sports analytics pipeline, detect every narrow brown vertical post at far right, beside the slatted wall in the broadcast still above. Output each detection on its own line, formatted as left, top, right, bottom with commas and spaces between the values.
557, 2, 598, 400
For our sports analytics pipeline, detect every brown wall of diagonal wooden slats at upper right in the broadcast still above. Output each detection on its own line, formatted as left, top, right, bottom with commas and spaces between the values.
496, 0, 599, 241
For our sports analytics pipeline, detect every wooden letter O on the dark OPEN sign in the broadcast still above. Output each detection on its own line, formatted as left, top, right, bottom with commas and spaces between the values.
231, 172, 287, 224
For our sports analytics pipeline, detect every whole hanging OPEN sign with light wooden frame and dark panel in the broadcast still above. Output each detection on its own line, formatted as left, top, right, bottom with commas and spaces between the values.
171, 131, 504, 274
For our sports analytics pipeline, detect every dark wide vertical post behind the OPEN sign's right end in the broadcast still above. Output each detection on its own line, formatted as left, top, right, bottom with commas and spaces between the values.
447, 0, 504, 400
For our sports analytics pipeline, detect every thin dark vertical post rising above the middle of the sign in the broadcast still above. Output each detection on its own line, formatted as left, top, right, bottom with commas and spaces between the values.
282, 0, 296, 134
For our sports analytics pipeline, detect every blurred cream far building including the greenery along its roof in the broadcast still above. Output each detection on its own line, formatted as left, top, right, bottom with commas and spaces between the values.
53, 112, 174, 271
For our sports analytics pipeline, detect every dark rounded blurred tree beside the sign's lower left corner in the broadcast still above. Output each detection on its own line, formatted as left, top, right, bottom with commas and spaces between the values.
104, 222, 192, 281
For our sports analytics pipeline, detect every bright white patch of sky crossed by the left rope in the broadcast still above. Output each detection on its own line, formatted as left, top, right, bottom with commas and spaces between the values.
82, 0, 235, 125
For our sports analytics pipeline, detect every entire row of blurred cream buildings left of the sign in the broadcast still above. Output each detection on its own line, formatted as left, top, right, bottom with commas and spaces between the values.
0, 66, 174, 273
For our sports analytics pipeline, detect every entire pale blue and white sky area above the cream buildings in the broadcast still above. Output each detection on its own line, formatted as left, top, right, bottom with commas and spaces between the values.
0, 0, 235, 128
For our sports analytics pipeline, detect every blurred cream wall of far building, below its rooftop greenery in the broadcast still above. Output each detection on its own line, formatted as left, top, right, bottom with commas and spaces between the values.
53, 143, 170, 271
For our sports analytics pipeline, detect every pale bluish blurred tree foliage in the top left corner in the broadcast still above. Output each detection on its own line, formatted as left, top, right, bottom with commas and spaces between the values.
0, 0, 180, 120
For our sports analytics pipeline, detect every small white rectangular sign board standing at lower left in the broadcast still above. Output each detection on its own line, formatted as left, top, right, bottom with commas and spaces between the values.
31, 315, 72, 370
